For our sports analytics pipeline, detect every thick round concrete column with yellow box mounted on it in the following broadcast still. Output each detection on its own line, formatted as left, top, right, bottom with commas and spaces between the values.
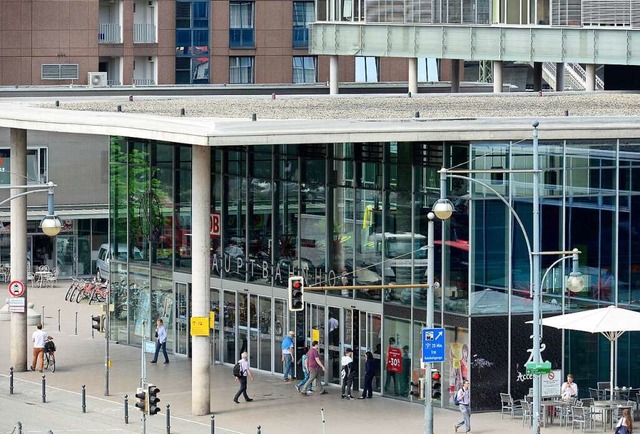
191, 146, 211, 416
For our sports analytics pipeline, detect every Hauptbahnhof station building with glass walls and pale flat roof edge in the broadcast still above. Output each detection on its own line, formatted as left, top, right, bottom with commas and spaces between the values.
0, 97, 640, 414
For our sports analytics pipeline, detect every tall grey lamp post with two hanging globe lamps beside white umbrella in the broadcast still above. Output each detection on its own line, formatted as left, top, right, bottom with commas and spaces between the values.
432, 121, 584, 434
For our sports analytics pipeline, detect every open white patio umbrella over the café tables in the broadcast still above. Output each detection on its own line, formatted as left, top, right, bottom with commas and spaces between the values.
541, 306, 640, 400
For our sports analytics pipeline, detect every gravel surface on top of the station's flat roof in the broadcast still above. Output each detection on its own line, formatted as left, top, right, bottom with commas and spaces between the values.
38, 92, 640, 120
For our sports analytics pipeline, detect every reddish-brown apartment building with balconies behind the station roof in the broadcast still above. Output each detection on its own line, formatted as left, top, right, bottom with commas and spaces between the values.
0, 0, 449, 87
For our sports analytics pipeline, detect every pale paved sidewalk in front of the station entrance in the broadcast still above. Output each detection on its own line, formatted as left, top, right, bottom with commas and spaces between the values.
0, 282, 602, 434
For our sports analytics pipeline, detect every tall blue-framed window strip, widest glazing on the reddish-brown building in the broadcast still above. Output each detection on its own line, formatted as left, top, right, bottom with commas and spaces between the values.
176, 1, 210, 84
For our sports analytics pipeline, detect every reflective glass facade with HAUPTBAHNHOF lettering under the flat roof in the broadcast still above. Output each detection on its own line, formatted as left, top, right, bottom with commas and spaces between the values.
110, 137, 640, 409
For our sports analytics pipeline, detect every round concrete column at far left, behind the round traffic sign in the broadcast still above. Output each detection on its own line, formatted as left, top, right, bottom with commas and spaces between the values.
10, 128, 31, 372
